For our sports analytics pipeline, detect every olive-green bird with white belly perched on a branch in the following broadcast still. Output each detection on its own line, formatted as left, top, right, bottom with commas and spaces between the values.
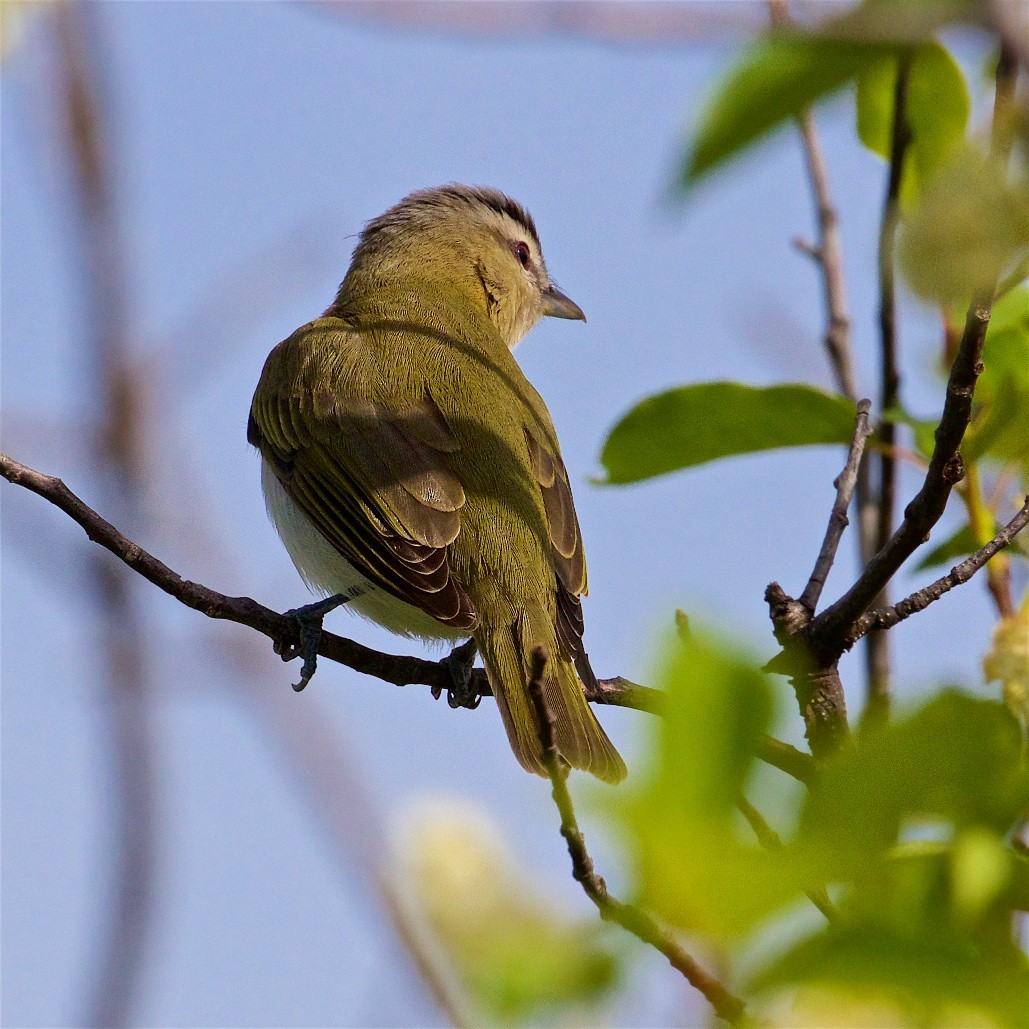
247, 183, 627, 783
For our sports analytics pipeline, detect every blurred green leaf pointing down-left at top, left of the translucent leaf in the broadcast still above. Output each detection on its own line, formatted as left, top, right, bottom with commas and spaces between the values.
682, 32, 897, 185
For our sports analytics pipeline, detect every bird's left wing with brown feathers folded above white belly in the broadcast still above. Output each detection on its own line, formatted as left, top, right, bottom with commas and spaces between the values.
248, 389, 478, 631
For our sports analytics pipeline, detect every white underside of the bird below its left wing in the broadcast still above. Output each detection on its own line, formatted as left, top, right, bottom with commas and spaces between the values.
260, 459, 468, 640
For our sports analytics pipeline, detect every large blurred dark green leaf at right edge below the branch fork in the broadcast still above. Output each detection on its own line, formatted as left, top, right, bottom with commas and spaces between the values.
800, 691, 1029, 879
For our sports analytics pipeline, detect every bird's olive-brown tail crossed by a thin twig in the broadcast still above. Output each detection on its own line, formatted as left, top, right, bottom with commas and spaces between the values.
475, 611, 626, 783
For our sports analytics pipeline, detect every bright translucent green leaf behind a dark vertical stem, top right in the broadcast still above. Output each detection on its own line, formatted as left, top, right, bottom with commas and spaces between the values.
857, 39, 971, 208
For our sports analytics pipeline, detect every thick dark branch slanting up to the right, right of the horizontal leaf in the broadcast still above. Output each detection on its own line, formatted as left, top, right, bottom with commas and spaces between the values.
810, 49, 1018, 654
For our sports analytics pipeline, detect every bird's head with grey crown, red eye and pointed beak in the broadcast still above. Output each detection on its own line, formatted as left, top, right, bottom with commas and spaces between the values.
341, 183, 586, 347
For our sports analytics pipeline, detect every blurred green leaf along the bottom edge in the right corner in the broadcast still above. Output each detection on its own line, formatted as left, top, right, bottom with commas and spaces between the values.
754, 922, 1029, 1026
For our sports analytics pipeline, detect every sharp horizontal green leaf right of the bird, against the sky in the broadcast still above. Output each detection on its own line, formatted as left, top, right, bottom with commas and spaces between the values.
601, 382, 855, 484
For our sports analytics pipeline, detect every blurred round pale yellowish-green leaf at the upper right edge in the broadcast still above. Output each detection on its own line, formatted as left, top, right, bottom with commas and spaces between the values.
899, 147, 1029, 305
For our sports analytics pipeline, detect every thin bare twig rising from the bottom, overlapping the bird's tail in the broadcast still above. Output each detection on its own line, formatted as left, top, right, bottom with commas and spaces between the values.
529, 647, 746, 1023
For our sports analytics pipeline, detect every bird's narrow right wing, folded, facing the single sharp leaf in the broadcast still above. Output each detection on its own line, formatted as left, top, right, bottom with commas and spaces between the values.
525, 421, 593, 670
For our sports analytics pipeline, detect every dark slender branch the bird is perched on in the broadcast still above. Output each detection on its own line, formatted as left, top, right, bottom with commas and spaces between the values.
0, 453, 814, 782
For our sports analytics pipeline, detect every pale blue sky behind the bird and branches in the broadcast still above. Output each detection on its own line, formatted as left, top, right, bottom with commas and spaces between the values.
0, 2, 1012, 1026
